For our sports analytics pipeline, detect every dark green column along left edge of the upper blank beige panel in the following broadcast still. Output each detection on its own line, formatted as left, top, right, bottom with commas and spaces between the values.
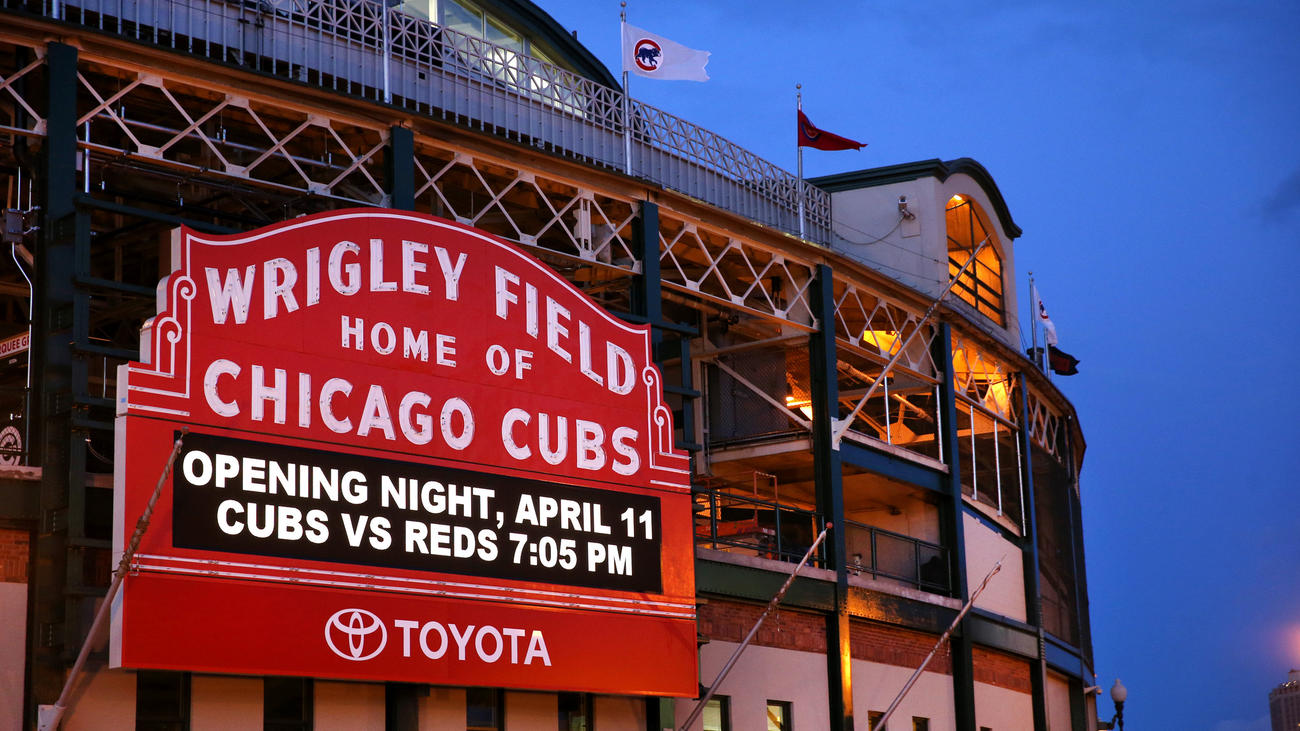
932, 323, 975, 731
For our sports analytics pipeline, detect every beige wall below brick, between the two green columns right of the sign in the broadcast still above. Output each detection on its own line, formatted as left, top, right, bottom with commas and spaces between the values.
852, 659, 957, 731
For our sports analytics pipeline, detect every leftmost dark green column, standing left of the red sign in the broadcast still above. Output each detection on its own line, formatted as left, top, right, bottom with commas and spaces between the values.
26, 43, 86, 724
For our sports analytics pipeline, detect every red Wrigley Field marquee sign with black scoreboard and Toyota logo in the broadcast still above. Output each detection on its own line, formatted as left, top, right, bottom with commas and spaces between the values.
111, 209, 698, 696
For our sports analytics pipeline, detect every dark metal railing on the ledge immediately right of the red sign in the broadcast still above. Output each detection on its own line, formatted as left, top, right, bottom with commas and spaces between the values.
692, 486, 826, 566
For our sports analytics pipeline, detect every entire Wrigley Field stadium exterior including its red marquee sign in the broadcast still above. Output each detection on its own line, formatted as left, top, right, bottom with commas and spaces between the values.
0, 0, 1097, 731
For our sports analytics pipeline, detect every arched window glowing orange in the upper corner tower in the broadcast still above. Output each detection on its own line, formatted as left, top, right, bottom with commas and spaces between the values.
946, 195, 1006, 325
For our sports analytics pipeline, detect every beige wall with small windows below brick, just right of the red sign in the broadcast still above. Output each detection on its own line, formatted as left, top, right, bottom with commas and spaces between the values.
681, 640, 831, 731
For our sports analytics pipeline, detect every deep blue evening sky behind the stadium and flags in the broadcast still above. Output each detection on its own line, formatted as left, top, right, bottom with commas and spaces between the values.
538, 0, 1300, 731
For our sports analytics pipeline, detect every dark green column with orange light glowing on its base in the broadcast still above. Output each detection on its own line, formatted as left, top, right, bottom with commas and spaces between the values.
809, 264, 853, 731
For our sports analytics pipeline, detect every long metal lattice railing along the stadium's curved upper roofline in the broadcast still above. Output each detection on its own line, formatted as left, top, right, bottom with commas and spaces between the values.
10, 0, 831, 242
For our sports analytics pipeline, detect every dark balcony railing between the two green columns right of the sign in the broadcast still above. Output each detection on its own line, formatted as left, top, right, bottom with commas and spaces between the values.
844, 520, 952, 594
